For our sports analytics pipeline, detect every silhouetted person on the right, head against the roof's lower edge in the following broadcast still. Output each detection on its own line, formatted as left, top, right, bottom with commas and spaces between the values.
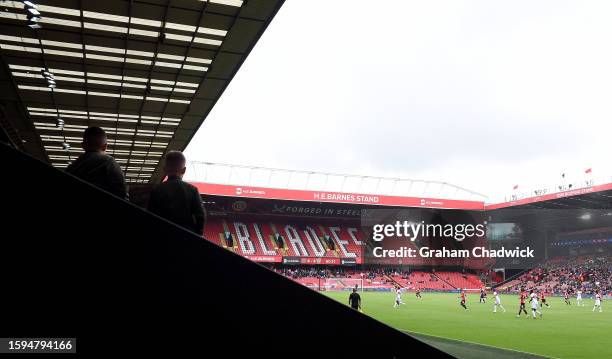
148, 151, 206, 235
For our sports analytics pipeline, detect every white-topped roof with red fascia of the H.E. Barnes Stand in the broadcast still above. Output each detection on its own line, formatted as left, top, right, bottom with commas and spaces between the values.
185, 161, 486, 209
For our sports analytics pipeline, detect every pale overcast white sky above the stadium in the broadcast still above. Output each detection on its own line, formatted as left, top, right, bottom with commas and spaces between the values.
187, 0, 612, 202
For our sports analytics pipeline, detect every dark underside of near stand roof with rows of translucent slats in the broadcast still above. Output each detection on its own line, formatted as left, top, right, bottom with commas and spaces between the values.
0, 0, 283, 183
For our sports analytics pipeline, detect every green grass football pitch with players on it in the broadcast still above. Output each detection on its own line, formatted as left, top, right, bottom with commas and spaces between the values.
324, 292, 612, 359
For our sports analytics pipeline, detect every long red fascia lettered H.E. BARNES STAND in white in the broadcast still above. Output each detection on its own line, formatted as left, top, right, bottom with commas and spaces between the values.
191, 182, 484, 210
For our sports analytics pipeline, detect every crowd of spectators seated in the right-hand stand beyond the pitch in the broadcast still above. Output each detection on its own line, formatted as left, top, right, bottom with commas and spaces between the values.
512, 255, 612, 294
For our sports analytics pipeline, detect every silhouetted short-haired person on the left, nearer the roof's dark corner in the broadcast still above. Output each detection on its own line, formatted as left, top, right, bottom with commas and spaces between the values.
66, 127, 128, 199
